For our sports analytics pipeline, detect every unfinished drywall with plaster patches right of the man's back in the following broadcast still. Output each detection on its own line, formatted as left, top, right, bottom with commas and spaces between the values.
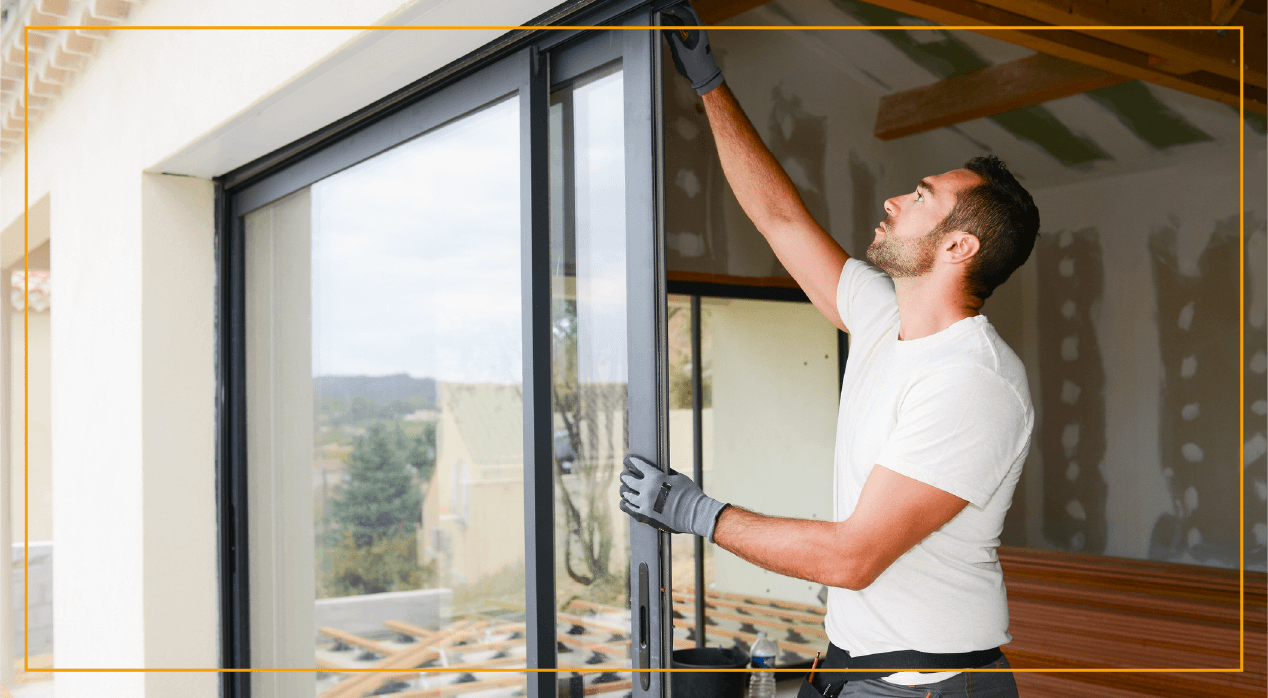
1032, 156, 1268, 570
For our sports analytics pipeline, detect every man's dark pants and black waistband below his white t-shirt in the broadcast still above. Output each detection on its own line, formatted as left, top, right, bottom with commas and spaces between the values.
798, 656, 1017, 698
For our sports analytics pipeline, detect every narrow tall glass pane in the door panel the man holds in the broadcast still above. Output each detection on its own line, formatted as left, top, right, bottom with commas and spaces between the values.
550, 69, 630, 694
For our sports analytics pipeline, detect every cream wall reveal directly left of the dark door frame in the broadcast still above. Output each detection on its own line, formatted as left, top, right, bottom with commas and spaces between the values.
139, 174, 219, 695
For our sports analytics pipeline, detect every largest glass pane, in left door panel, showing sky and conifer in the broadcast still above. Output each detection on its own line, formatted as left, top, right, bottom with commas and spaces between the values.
247, 96, 525, 695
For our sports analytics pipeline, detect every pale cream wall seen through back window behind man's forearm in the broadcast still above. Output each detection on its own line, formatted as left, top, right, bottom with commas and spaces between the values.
705, 301, 839, 604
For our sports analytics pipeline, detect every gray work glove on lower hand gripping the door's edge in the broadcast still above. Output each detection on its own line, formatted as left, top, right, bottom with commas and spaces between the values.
621, 454, 728, 543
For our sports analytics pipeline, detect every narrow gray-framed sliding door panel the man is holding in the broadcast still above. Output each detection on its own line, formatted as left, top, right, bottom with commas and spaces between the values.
550, 13, 668, 695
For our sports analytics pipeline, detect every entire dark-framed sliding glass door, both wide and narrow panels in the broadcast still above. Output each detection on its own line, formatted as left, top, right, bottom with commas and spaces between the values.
219, 3, 670, 698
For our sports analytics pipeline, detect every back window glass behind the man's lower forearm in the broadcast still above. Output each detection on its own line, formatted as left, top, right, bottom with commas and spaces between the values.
670, 298, 839, 665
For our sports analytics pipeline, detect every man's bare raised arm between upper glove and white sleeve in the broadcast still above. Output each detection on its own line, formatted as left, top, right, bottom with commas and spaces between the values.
704, 82, 850, 331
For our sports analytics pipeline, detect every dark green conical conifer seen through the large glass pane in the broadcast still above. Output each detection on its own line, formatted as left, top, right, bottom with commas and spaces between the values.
331, 424, 422, 548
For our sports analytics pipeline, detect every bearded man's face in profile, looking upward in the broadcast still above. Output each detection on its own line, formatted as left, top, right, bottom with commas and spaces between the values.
867, 170, 981, 279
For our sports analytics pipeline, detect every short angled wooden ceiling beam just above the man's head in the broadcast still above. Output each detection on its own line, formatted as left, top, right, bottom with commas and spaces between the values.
876, 53, 1126, 141
